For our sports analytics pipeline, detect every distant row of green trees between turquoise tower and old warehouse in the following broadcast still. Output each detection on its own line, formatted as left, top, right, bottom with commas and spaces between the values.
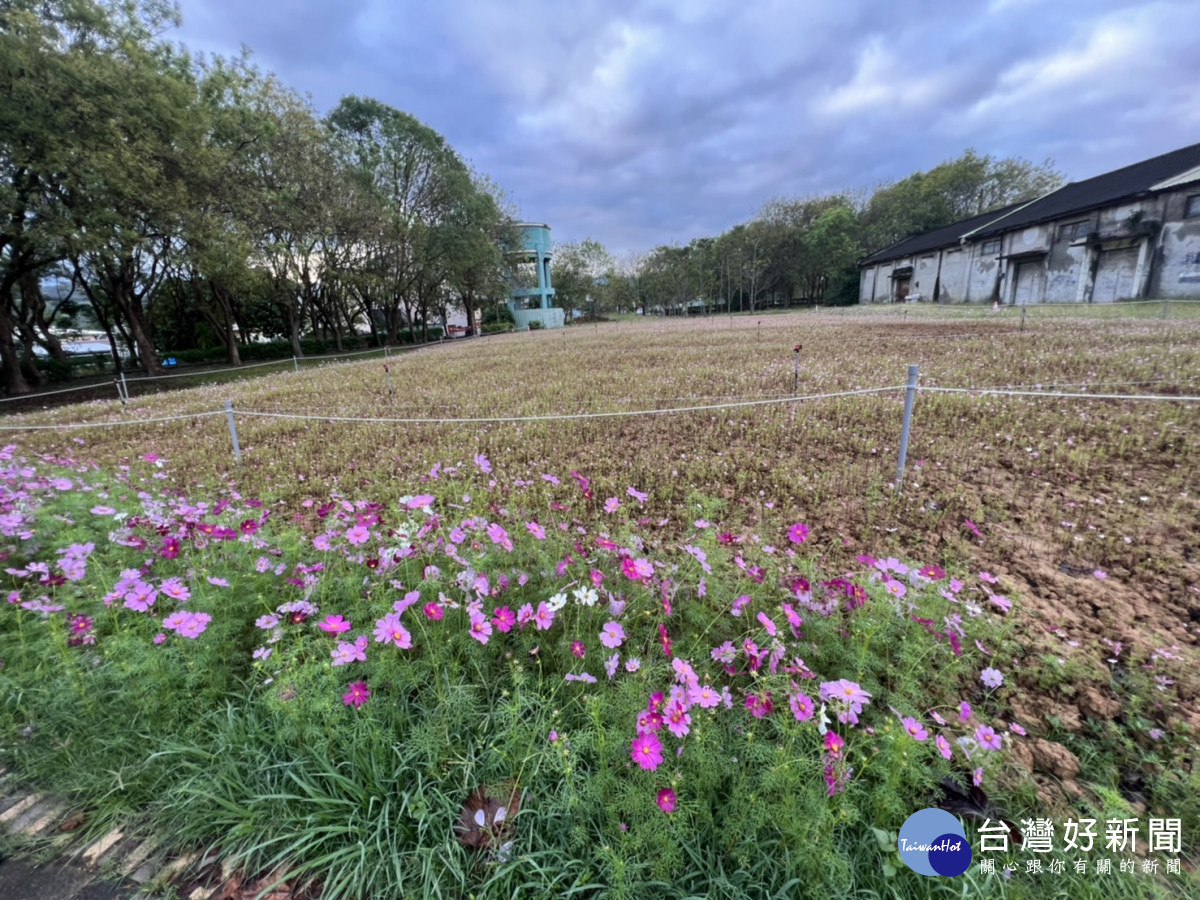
554, 150, 1062, 313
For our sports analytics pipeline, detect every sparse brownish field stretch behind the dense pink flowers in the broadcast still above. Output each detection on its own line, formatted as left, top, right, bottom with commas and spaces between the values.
11, 311, 1200, 731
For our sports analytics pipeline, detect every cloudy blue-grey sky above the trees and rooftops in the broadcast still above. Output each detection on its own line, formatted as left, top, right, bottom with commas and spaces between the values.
180, 0, 1200, 256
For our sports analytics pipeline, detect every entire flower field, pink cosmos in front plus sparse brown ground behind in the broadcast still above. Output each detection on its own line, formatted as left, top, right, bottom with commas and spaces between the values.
0, 314, 1200, 898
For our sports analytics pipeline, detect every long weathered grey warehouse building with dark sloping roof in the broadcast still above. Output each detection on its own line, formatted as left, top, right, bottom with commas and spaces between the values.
859, 144, 1200, 305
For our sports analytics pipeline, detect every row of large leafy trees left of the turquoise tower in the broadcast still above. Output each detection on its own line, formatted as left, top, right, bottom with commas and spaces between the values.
0, 0, 512, 394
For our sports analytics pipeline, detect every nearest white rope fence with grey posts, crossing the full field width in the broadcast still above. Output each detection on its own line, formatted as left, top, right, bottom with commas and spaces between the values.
0, 365, 1200, 491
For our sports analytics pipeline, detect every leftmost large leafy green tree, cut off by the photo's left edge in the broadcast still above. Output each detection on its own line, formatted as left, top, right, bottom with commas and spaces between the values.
0, 0, 186, 394
